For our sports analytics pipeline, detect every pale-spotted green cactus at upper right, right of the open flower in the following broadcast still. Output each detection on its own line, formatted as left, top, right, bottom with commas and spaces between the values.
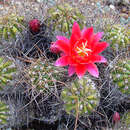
105, 24, 130, 50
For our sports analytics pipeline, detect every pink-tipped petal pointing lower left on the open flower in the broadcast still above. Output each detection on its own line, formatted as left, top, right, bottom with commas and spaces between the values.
55, 56, 69, 66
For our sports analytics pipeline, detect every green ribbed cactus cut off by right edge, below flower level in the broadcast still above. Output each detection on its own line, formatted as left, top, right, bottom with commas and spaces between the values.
111, 59, 130, 94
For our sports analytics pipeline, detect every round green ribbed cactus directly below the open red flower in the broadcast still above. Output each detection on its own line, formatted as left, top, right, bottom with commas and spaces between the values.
61, 77, 99, 116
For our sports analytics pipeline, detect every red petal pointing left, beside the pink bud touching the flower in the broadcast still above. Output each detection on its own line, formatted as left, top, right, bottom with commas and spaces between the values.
56, 40, 70, 54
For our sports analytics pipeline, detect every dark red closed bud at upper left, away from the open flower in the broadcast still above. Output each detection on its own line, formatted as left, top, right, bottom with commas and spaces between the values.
29, 19, 40, 32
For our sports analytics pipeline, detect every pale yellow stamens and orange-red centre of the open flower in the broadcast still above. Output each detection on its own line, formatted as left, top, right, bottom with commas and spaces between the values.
75, 41, 92, 57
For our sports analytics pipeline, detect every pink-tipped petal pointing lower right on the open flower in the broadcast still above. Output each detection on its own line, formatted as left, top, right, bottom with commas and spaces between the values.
86, 63, 99, 78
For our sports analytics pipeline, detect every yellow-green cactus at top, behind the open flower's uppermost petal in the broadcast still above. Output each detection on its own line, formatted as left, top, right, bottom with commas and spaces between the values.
48, 3, 85, 35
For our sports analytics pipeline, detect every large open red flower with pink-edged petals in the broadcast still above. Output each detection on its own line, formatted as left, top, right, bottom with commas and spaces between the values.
50, 22, 108, 78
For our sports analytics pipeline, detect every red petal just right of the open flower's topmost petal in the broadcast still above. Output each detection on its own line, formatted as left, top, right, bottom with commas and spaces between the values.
82, 27, 93, 41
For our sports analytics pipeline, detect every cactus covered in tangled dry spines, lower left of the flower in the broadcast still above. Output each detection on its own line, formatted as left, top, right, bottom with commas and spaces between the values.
25, 58, 65, 91
